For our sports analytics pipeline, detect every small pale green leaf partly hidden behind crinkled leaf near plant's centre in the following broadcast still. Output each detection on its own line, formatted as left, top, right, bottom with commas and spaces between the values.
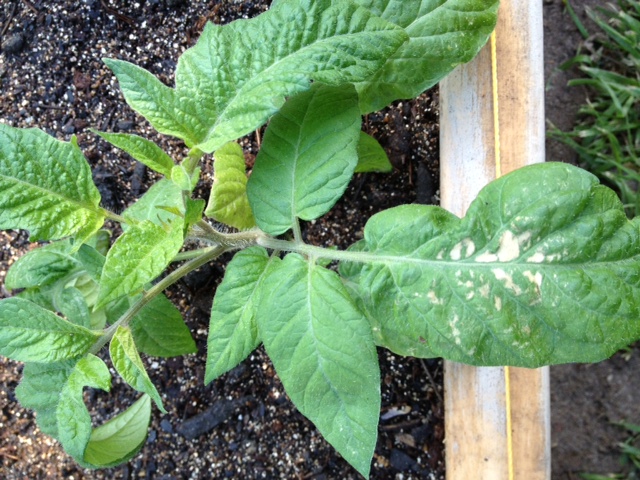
122, 178, 182, 231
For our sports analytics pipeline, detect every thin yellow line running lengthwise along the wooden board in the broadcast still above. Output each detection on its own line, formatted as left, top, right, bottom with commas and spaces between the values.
491, 30, 515, 480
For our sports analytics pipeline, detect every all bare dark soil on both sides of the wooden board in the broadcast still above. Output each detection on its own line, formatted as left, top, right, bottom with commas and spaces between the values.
0, 0, 640, 480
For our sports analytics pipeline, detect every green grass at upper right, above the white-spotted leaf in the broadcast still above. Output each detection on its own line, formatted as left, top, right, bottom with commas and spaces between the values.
549, 0, 640, 217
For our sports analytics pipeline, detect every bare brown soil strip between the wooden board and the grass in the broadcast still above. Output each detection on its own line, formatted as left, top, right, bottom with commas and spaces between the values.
544, 0, 640, 480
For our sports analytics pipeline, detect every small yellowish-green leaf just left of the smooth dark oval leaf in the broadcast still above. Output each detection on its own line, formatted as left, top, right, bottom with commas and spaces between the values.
205, 142, 256, 230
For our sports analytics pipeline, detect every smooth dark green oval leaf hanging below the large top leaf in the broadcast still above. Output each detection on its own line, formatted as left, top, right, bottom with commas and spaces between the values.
247, 86, 361, 235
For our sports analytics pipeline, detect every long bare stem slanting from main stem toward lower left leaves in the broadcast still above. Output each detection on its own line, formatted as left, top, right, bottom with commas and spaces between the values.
89, 246, 227, 355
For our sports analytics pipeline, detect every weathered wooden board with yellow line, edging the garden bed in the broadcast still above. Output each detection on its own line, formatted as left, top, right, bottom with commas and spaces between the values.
440, 0, 551, 480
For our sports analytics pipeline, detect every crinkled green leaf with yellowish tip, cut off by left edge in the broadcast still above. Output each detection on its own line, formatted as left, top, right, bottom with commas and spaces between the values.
0, 124, 105, 243
